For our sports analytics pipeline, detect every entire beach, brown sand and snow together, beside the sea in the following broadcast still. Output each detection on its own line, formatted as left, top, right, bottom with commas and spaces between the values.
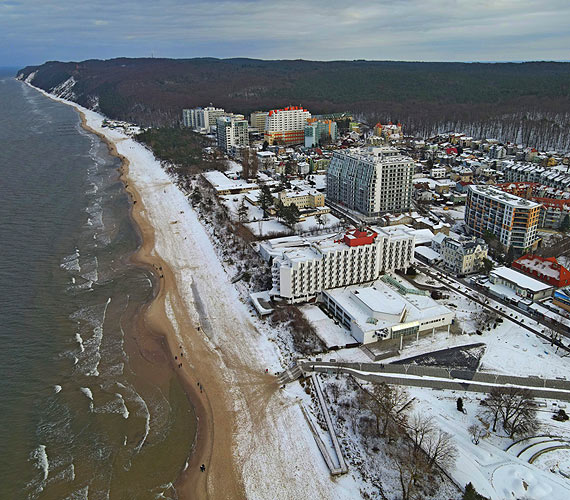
30, 83, 360, 499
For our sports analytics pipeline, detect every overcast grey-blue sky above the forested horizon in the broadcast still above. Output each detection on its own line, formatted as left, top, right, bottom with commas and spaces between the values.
0, 0, 570, 66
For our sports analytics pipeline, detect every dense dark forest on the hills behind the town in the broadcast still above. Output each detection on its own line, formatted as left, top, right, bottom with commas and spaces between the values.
18, 58, 570, 149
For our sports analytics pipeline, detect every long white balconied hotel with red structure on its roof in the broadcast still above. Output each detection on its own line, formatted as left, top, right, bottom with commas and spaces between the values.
260, 226, 414, 303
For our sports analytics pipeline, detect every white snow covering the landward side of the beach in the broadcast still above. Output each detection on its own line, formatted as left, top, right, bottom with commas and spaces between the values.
27, 88, 361, 499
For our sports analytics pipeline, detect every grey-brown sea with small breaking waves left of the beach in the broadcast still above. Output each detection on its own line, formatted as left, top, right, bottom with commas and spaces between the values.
0, 71, 196, 500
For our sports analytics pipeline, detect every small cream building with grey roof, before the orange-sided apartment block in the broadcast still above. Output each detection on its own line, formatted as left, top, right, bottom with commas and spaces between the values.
440, 236, 489, 276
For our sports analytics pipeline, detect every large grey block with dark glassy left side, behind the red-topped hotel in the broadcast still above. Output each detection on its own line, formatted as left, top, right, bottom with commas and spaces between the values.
327, 147, 414, 217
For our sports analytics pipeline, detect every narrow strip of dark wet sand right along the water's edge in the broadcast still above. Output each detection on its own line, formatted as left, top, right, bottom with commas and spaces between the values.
75, 108, 229, 499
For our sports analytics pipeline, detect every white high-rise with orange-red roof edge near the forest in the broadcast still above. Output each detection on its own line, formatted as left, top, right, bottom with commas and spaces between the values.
264, 106, 311, 145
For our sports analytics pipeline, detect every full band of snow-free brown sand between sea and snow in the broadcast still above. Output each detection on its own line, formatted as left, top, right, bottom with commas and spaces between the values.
78, 110, 245, 499
